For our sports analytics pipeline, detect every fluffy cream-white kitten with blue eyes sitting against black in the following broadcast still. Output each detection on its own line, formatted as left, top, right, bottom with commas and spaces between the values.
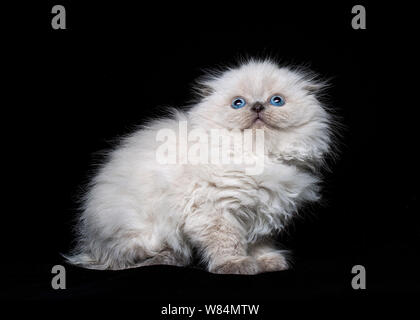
67, 60, 332, 274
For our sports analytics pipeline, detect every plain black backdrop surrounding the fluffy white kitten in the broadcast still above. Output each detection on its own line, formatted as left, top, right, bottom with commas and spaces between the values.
1, 2, 420, 317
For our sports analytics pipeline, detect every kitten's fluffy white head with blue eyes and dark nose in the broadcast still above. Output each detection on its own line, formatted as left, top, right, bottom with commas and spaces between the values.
190, 60, 331, 165
